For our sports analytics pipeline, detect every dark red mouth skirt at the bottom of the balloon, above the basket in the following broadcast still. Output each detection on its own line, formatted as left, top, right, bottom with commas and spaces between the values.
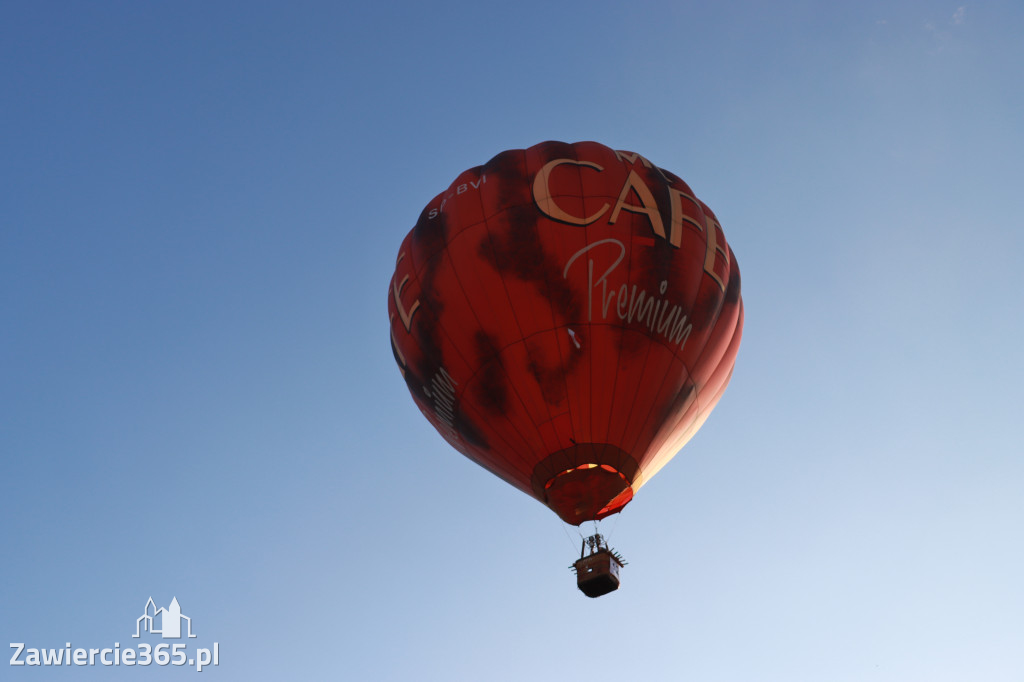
532, 443, 639, 525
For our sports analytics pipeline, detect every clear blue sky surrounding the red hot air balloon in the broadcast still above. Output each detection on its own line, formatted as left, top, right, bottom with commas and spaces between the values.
0, 0, 1024, 682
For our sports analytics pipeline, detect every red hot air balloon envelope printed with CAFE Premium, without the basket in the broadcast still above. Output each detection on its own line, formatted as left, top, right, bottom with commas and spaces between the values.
388, 142, 743, 525
